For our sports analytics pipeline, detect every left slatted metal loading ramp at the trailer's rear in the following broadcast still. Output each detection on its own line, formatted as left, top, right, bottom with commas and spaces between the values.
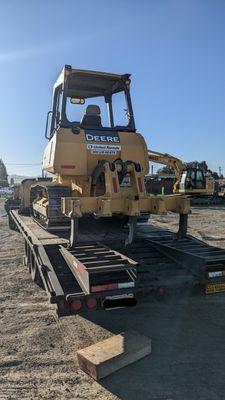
60, 242, 137, 294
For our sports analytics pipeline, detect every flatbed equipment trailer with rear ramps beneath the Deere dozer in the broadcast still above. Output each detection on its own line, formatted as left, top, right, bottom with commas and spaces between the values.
9, 210, 225, 316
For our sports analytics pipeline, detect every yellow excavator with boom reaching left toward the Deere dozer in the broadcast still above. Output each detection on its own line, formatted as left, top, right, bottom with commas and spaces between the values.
148, 150, 216, 198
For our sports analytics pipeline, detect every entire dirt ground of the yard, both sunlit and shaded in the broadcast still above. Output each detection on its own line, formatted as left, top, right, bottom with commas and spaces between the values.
0, 200, 225, 400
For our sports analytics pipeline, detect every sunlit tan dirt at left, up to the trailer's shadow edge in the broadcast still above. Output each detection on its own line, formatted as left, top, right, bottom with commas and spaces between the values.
0, 200, 117, 400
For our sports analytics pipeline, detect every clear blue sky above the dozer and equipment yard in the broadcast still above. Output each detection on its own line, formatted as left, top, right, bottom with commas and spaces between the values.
0, 0, 225, 175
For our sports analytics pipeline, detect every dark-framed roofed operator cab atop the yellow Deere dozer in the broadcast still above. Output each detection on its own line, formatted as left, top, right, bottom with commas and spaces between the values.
46, 65, 135, 137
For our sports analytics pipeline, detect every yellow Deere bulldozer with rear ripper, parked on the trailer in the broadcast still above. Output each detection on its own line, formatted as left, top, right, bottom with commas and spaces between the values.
31, 65, 190, 244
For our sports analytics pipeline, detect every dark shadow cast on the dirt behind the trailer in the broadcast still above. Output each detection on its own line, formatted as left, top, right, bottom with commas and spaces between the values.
82, 295, 225, 400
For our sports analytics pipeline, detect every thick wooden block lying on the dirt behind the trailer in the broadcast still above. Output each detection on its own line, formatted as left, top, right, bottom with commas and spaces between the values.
77, 331, 151, 380
